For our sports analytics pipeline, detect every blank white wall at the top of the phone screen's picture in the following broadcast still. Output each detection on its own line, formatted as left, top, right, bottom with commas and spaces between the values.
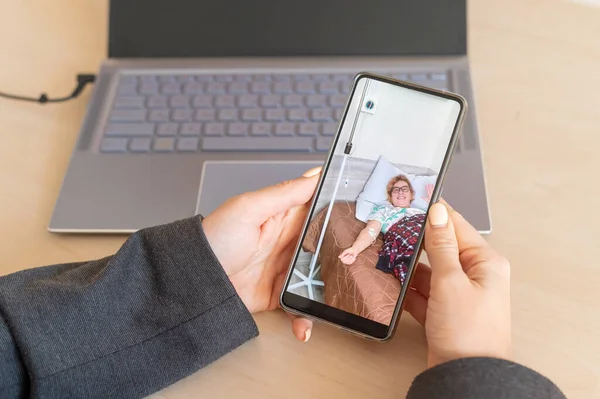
336, 79, 459, 172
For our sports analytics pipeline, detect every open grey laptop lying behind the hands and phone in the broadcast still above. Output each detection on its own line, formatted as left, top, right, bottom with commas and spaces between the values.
48, 0, 491, 233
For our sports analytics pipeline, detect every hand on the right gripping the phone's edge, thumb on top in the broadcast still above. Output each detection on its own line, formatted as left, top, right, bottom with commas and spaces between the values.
405, 203, 511, 367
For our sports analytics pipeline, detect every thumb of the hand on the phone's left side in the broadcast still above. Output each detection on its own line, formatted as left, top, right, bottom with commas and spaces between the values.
246, 167, 321, 224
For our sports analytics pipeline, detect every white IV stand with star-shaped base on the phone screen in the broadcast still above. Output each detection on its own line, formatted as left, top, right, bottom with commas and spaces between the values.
288, 79, 370, 300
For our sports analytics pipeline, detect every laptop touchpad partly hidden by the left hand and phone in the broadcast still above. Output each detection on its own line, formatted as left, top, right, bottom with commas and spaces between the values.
196, 161, 323, 216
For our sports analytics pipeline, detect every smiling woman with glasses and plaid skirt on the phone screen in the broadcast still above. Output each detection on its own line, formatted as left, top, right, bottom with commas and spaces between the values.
339, 175, 434, 283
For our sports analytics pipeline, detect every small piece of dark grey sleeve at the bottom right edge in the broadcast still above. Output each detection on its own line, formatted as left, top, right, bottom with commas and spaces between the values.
406, 357, 566, 399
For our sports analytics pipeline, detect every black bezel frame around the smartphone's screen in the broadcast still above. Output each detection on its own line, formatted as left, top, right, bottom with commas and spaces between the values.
279, 72, 468, 342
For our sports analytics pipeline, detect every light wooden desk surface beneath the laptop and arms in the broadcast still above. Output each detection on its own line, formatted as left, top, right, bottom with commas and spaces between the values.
0, 0, 600, 399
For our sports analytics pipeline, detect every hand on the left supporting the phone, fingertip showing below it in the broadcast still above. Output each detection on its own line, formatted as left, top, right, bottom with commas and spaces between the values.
202, 168, 321, 342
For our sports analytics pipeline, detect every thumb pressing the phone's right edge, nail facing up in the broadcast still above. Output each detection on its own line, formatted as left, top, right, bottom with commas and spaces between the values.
425, 203, 462, 279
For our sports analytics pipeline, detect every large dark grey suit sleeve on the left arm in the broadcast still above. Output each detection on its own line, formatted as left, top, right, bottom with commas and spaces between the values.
0, 217, 258, 398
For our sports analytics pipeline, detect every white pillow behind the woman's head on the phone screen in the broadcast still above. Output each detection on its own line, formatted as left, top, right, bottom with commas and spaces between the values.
355, 156, 415, 223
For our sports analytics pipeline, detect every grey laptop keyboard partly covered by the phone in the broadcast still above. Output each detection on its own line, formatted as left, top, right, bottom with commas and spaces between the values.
100, 71, 448, 153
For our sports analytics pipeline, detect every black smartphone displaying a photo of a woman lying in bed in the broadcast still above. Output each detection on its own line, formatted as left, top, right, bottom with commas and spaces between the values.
280, 73, 467, 341
